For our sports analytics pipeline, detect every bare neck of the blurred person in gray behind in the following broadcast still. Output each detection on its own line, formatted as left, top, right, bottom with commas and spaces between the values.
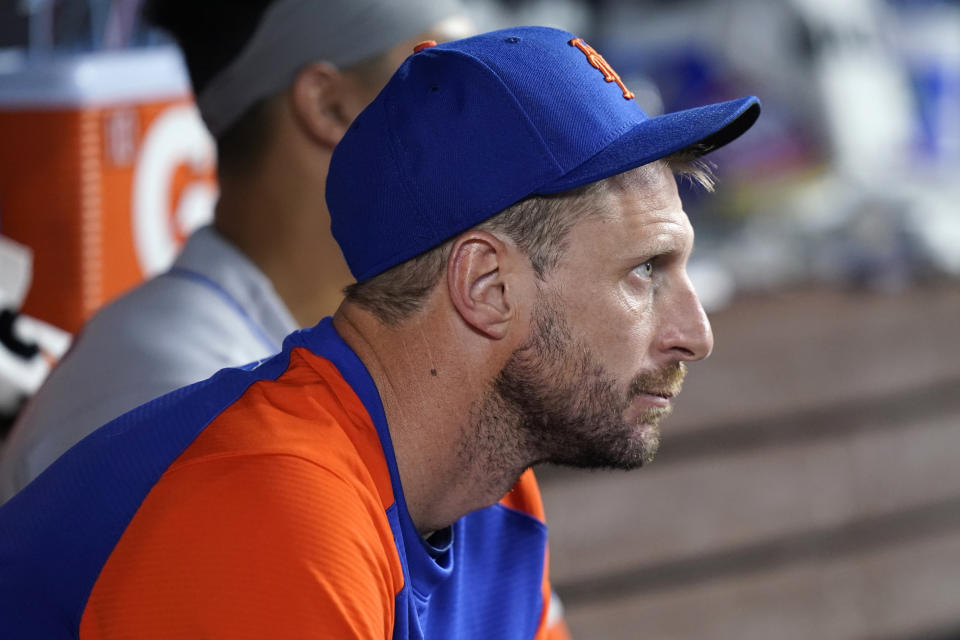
214, 160, 351, 327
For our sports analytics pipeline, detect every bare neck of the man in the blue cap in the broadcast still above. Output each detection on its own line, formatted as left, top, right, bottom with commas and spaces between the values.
334, 303, 526, 535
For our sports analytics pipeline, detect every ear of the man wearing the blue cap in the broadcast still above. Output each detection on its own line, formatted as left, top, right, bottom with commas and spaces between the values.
447, 231, 516, 340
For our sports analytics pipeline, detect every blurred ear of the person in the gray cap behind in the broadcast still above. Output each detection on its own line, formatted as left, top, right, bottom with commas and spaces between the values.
291, 62, 351, 149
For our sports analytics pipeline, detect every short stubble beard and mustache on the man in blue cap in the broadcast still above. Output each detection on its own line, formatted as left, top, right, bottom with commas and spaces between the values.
460, 295, 685, 498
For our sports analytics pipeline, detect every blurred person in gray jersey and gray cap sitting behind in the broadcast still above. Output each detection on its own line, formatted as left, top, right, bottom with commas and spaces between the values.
0, 0, 471, 503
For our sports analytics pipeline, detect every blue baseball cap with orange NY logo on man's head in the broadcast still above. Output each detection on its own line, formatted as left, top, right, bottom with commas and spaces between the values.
326, 27, 760, 282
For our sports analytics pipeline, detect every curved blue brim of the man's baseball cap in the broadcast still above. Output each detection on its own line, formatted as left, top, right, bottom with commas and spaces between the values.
536, 96, 760, 194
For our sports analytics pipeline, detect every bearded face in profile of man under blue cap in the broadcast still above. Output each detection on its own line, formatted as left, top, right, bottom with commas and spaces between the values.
495, 163, 713, 469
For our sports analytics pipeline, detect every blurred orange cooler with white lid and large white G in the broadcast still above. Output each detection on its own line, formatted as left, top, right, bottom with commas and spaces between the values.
0, 47, 216, 332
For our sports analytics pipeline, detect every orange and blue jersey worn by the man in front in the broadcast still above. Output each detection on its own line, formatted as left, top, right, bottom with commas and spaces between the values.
0, 319, 564, 640
